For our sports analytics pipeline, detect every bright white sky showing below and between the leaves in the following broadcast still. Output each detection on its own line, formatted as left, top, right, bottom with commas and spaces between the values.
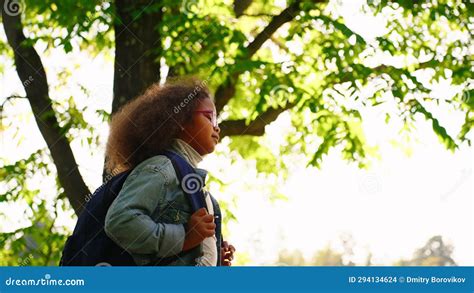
0, 1, 474, 265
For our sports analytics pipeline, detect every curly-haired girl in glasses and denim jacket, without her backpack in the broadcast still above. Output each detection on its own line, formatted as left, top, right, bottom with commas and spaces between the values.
105, 78, 235, 266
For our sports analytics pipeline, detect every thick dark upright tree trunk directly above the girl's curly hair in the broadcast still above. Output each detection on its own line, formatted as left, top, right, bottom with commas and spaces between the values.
112, 0, 163, 113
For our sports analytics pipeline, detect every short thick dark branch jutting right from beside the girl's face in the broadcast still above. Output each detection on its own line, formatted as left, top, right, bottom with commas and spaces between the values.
219, 103, 295, 137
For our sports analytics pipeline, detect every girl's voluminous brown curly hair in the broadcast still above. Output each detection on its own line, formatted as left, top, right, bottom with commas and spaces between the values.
105, 77, 211, 174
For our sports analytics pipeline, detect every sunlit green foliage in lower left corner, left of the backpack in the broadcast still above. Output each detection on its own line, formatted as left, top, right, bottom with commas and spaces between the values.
0, 150, 71, 266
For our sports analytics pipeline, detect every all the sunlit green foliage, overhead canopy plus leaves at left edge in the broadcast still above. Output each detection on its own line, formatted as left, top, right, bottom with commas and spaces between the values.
0, 0, 474, 265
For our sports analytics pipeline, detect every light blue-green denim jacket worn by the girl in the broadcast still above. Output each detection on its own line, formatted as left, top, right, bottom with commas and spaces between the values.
105, 144, 222, 266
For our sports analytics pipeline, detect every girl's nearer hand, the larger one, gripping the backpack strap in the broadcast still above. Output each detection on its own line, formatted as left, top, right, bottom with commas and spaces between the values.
183, 208, 216, 250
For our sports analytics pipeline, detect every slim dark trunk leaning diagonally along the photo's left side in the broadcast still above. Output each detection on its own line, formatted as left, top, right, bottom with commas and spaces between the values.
0, 0, 90, 215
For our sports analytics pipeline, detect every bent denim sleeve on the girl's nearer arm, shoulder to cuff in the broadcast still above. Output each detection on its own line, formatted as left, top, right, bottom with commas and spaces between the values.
104, 162, 185, 257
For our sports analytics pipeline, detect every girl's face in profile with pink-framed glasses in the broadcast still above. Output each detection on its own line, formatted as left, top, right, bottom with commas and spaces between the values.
180, 98, 221, 156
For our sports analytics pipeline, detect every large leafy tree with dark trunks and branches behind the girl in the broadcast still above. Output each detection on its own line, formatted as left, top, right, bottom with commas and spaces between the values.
0, 0, 474, 264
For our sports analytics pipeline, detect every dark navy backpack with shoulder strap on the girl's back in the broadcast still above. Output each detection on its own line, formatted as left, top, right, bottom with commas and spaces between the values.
59, 151, 206, 266
